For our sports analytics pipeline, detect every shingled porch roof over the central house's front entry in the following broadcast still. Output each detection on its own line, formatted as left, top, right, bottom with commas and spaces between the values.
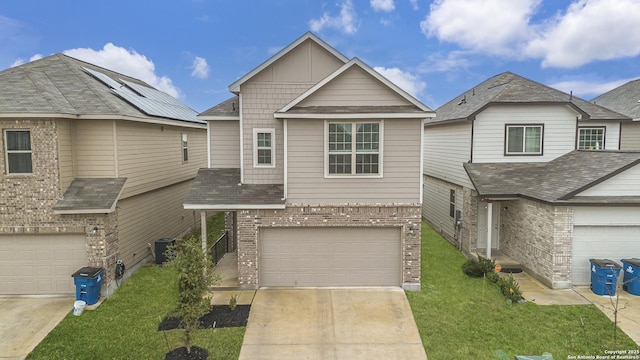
184, 169, 285, 210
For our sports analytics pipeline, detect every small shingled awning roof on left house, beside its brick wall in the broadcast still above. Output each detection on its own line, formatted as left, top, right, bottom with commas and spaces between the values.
53, 178, 127, 214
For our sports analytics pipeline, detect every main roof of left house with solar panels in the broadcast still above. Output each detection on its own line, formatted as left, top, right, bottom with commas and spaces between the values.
0, 54, 203, 126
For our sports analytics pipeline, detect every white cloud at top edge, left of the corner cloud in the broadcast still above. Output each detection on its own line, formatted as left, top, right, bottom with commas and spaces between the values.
420, 0, 540, 55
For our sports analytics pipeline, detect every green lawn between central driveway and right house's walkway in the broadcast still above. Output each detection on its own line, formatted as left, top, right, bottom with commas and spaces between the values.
407, 223, 638, 360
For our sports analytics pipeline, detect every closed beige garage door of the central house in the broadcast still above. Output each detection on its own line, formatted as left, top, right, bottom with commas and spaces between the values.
258, 228, 402, 287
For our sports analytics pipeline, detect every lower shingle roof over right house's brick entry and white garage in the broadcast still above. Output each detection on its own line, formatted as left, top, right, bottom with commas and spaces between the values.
464, 150, 640, 203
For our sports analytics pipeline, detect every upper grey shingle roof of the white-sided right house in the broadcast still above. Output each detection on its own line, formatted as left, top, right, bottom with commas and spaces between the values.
427, 72, 630, 124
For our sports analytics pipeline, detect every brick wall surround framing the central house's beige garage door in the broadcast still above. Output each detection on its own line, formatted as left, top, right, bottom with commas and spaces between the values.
237, 204, 421, 290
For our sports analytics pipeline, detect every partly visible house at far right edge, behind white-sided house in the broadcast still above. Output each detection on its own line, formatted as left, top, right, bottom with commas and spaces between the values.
592, 80, 640, 150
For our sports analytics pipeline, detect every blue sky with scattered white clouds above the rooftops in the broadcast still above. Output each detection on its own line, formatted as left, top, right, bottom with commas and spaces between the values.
0, 0, 640, 111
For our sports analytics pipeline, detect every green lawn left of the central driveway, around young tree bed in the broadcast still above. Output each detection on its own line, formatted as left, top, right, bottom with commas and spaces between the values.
27, 266, 245, 359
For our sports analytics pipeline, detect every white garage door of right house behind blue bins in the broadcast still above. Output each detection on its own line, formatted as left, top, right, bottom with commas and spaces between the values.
571, 226, 640, 285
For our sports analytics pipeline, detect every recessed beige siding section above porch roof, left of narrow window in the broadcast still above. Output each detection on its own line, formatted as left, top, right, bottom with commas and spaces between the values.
209, 120, 240, 169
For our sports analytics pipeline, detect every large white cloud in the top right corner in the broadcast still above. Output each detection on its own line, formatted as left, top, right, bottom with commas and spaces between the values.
527, 0, 640, 68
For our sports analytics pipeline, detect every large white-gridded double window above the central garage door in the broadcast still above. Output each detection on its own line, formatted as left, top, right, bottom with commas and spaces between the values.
327, 122, 382, 175
